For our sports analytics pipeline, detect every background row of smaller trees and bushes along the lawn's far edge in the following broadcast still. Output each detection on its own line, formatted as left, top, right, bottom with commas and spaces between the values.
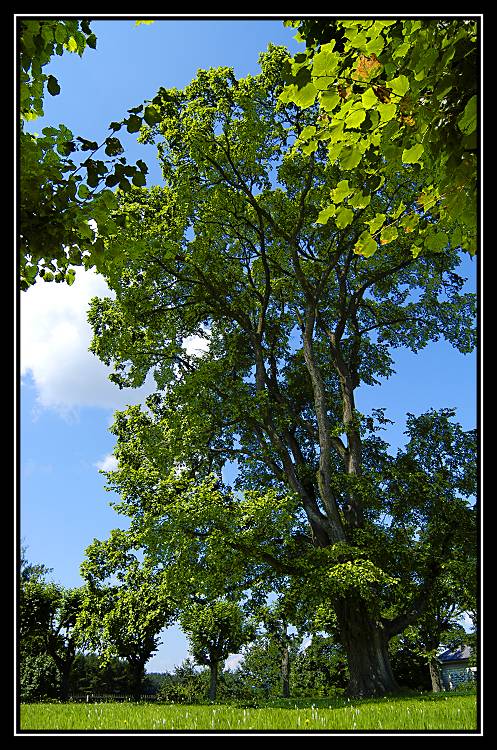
18, 547, 475, 703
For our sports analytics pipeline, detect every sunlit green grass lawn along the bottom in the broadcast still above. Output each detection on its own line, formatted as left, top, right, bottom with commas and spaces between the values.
20, 693, 477, 732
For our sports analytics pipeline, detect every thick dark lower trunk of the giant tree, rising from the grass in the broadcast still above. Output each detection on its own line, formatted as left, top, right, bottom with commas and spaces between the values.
335, 598, 399, 698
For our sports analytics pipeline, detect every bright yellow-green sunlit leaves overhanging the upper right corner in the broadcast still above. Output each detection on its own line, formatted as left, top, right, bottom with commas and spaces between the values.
280, 18, 479, 257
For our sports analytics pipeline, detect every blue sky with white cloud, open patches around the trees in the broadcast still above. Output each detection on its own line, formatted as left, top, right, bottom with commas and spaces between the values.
20, 18, 476, 671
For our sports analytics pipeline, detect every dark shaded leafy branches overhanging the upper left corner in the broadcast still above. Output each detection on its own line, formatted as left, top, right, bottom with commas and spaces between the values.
18, 19, 156, 290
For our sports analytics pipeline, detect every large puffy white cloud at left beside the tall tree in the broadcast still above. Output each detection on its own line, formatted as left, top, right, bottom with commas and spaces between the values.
20, 269, 154, 417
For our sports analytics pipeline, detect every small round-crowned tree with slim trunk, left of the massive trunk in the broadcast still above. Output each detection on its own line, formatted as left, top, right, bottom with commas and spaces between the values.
180, 599, 254, 701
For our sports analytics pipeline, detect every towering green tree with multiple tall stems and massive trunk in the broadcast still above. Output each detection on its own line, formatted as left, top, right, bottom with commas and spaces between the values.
86, 47, 475, 695
